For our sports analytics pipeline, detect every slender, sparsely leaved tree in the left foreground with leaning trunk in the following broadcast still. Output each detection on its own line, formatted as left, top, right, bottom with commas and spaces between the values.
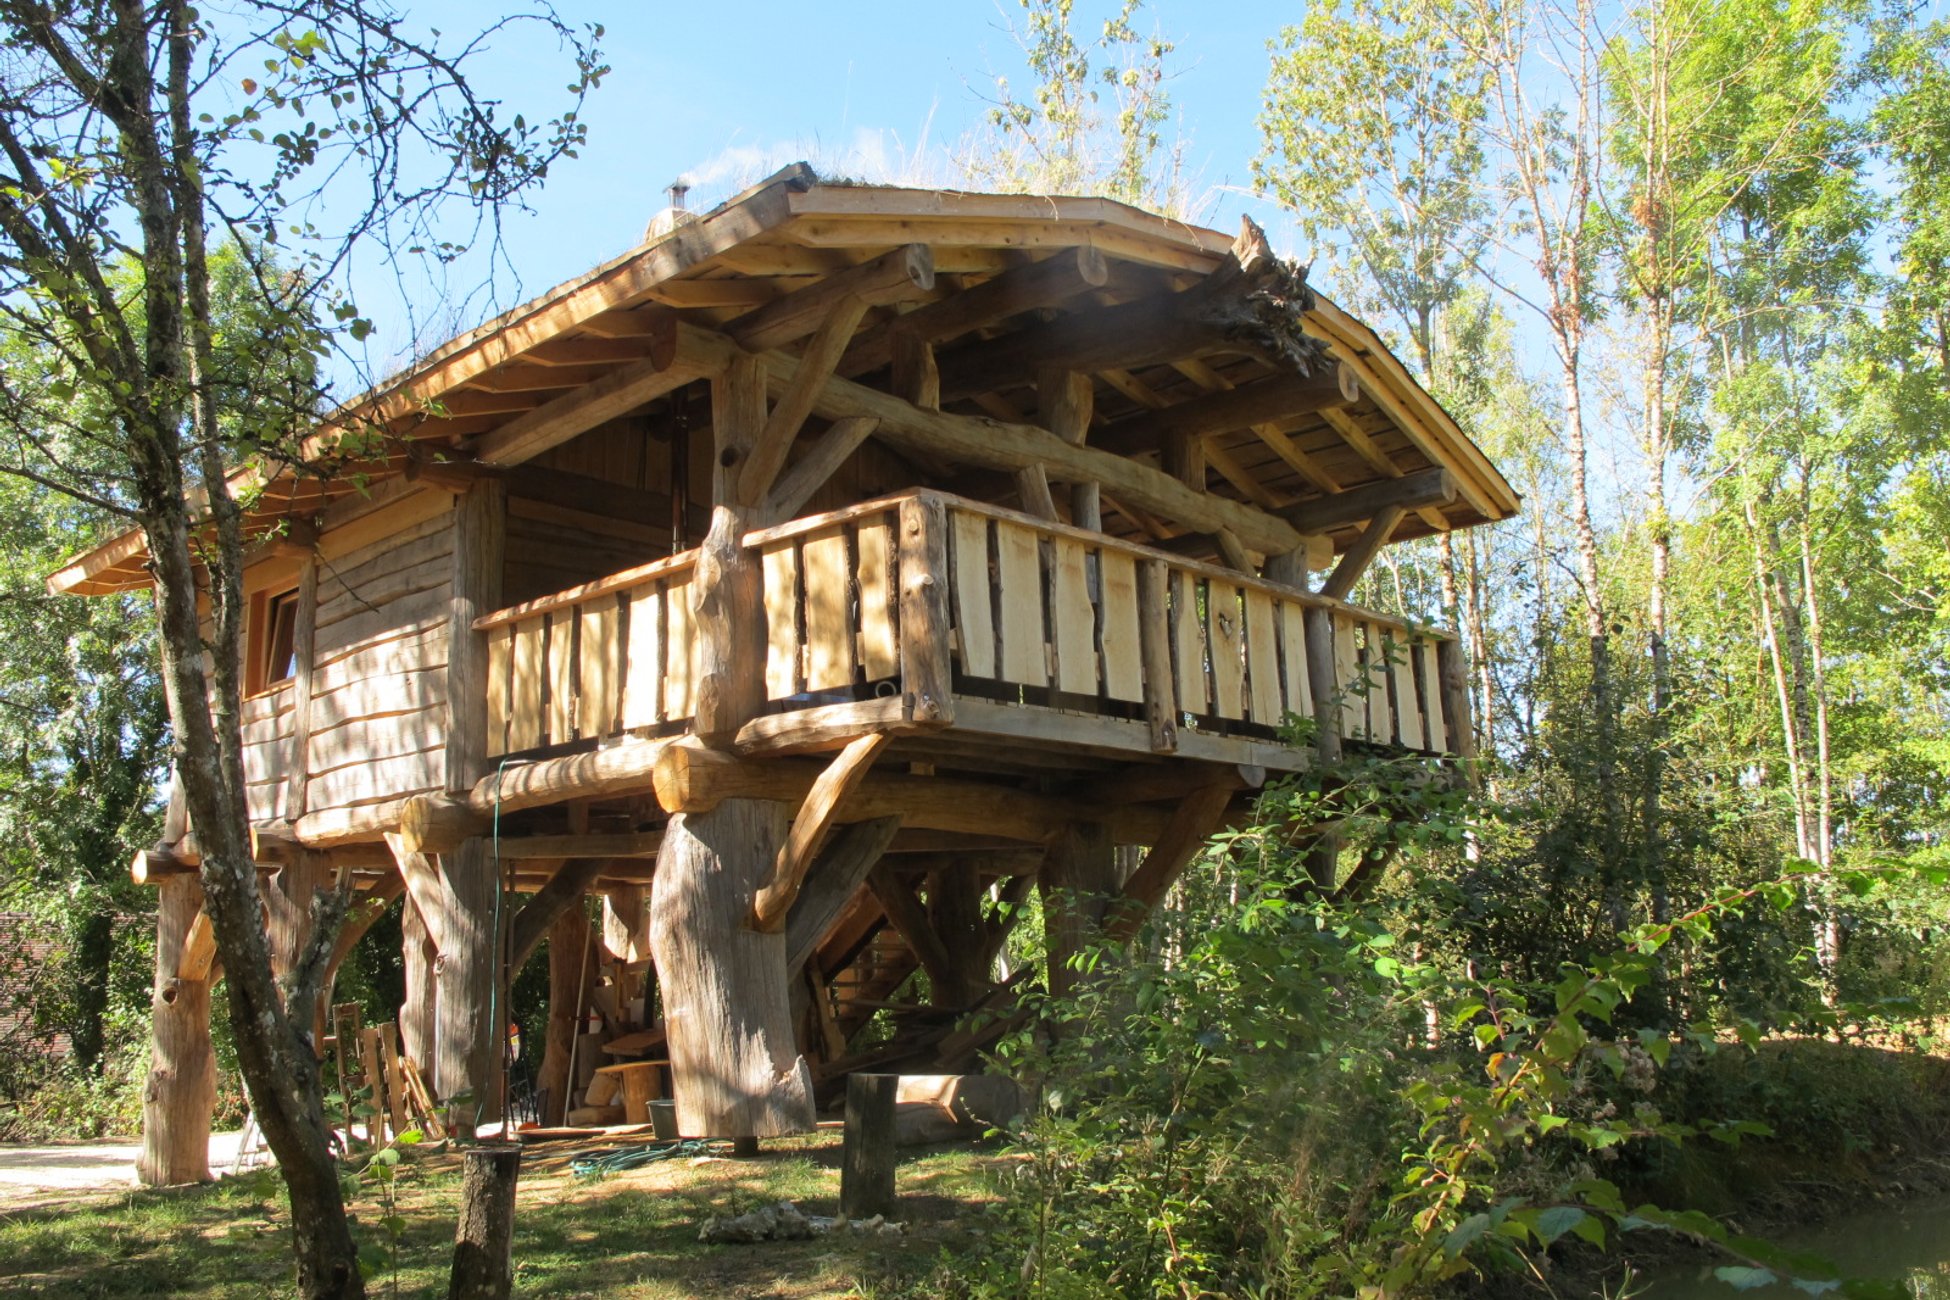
0, 0, 603, 1296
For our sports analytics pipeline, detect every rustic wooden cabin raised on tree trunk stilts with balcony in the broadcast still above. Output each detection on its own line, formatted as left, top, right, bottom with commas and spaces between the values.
51, 166, 1517, 1181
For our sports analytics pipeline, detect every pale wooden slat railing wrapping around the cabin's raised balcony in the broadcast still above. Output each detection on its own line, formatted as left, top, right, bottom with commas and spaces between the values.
474, 491, 1461, 770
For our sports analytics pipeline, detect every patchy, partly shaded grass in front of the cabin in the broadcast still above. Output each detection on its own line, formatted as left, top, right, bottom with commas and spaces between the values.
0, 1132, 998, 1300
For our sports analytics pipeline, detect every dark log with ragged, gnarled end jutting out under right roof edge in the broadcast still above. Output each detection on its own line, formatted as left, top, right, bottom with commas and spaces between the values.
942, 222, 1326, 401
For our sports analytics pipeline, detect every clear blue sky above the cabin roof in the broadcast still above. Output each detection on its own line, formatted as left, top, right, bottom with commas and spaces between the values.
361, 0, 1307, 370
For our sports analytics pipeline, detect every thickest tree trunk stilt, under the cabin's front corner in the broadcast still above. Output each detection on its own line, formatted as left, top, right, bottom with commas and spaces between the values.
649, 799, 813, 1138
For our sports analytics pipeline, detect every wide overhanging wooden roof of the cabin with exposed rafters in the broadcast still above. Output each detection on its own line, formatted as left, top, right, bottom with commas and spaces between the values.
49, 164, 1517, 594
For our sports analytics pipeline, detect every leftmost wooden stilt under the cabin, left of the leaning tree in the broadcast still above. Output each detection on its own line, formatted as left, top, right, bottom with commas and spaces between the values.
135, 875, 216, 1187
